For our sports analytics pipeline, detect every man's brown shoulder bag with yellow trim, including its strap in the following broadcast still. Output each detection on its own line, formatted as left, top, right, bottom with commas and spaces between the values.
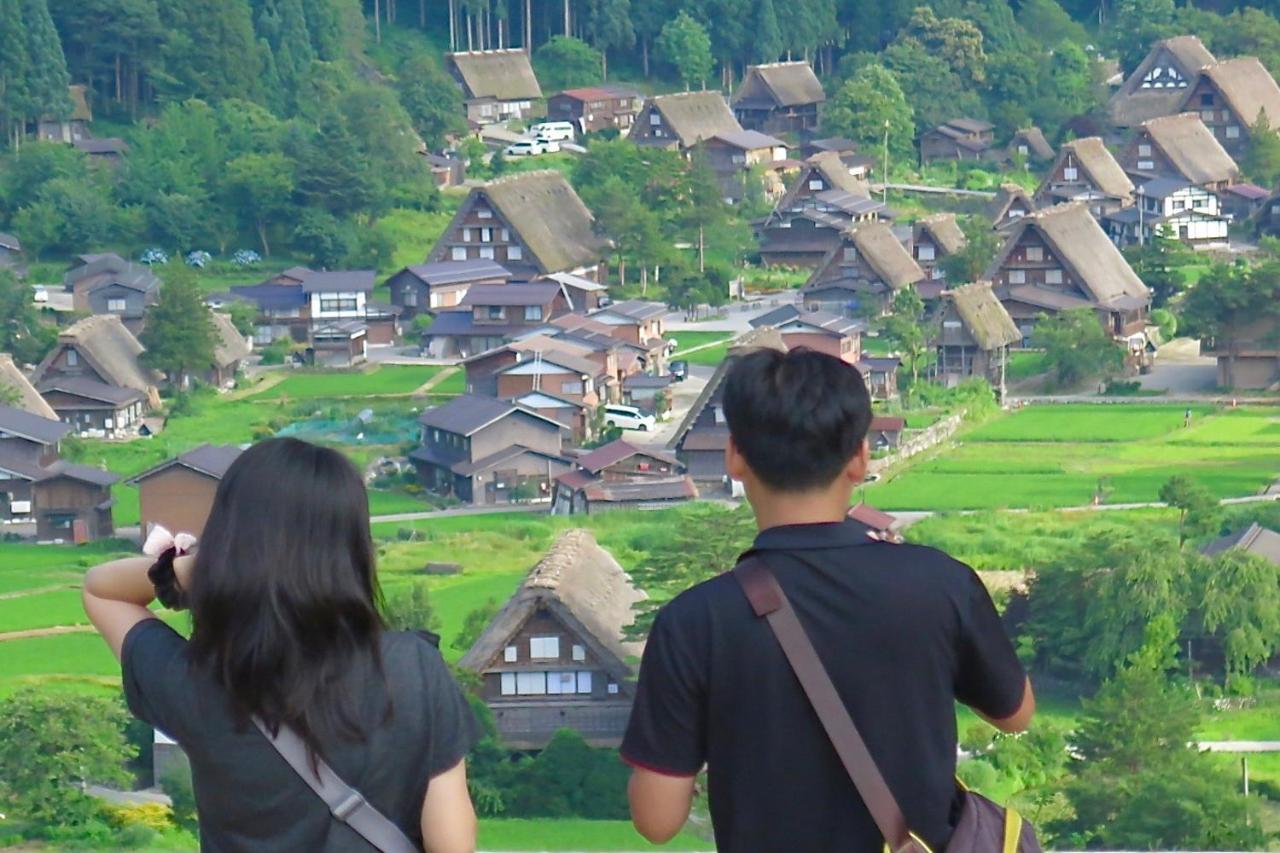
733, 555, 1041, 853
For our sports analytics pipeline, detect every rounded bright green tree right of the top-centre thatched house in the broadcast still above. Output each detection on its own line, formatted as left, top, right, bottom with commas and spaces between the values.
823, 64, 915, 162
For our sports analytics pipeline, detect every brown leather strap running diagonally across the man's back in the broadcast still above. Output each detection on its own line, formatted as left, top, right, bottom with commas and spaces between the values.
733, 555, 919, 850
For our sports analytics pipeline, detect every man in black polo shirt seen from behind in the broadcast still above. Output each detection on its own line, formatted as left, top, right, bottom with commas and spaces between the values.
622, 350, 1036, 853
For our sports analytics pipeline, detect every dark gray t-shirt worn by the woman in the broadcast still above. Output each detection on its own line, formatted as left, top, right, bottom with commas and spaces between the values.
122, 619, 480, 853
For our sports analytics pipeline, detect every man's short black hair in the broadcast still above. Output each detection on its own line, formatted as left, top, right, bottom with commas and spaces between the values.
722, 350, 872, 492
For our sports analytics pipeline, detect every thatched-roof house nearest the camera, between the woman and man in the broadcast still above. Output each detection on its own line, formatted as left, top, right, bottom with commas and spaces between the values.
460, 529, 646, 749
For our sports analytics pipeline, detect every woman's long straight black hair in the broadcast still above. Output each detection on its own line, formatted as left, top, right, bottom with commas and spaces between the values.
189, 438, 383, 753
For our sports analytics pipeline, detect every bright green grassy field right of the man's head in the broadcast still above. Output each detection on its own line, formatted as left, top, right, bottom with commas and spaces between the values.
867, 405, 1280, 510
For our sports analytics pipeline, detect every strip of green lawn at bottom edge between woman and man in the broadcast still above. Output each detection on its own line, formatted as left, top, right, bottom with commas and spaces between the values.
479, 820, 716, 852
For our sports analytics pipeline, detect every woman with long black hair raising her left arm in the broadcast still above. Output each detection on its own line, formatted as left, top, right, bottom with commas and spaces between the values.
84, 439, 477, 853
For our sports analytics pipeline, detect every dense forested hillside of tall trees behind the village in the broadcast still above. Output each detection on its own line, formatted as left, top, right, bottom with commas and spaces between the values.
0, 0, 1280, 269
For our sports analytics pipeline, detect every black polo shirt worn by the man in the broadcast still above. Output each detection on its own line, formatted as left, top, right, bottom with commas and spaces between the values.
622, 521, 1025, 853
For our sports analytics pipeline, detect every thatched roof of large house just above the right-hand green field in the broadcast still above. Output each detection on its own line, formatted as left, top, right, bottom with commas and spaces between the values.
986, 202, 1151, 307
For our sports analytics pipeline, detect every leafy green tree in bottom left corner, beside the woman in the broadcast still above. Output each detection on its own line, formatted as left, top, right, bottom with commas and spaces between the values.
0, 688, 131, 833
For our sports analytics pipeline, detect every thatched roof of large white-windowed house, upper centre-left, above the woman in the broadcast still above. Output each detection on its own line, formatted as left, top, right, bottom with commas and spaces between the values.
458, 169, 607, 274
